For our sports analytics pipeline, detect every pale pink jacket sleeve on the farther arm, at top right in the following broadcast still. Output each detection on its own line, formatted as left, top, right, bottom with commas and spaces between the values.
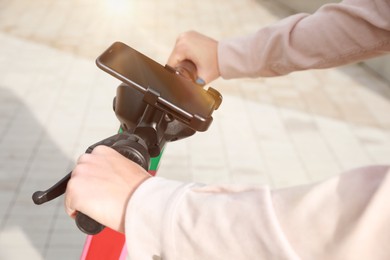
218, 0, 390, 79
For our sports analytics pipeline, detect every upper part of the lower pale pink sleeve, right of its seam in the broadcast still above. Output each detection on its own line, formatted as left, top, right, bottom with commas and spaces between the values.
272, 166, 390, 260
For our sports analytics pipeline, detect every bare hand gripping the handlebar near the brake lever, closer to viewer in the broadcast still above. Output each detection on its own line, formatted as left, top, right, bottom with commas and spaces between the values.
65, 146, 150, 232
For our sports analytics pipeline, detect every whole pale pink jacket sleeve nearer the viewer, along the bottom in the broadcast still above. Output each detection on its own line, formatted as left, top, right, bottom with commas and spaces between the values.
125, 167, 390, 260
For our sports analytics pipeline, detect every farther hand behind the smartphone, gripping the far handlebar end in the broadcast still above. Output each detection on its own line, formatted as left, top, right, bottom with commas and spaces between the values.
167, 31, 220, 83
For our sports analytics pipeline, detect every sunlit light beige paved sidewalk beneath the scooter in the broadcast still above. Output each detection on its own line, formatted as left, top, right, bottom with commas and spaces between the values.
0, 0, 390, 260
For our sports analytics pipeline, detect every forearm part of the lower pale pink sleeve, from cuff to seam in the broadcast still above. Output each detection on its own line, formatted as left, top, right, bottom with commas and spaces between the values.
125, 178, 297, 260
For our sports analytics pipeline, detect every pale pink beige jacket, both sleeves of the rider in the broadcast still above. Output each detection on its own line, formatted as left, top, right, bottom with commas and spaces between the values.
125, 0, 390, 260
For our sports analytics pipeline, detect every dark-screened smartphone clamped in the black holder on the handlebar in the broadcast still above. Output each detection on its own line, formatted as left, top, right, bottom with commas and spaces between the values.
96, 42, 222, 131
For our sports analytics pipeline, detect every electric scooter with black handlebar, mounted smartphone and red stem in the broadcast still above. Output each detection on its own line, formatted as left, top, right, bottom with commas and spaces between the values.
32, 42, 222, 260
